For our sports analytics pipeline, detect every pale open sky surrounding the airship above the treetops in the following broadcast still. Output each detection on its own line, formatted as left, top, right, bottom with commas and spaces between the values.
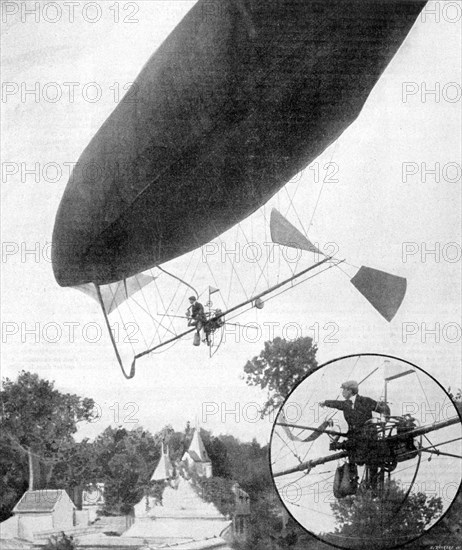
1, 0, 462, 452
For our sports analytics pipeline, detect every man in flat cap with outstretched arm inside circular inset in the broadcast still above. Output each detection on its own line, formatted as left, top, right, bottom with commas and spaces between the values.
319, 380, 390, 489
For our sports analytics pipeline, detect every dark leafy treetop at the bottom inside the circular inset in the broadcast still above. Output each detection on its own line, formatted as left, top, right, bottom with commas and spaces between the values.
325, 481, 443, 549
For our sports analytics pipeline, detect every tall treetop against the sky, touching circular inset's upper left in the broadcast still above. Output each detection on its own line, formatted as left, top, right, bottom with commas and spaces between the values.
244, 337, 318, 416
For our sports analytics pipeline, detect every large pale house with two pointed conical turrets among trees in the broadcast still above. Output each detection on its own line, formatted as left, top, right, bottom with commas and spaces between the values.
130, 428, 250, 549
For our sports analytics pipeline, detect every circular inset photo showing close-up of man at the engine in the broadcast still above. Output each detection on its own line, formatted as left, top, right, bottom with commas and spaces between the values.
270, 354, 462, 549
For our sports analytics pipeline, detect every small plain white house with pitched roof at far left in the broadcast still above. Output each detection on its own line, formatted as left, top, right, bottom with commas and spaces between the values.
13, 489, 76, 539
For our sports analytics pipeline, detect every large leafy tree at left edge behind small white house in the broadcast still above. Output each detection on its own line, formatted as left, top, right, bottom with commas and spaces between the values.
0, 371, 95, 519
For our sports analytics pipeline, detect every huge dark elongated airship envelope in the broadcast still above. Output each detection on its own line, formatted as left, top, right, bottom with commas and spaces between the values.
52, 0, 425, 286
